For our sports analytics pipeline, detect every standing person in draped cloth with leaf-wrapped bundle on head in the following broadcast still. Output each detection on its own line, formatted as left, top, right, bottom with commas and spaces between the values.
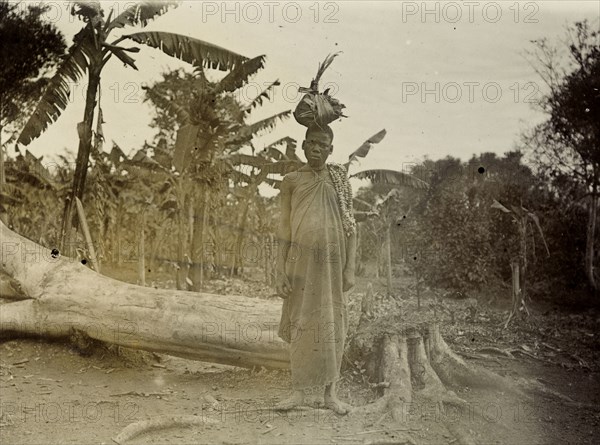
276, 56, 356, 414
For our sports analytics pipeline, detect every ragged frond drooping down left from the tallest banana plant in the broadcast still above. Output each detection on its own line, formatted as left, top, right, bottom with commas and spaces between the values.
17, 35, 94, 145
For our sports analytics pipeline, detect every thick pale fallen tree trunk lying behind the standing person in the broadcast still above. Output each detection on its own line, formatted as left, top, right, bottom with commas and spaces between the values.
0, 222, 289, 368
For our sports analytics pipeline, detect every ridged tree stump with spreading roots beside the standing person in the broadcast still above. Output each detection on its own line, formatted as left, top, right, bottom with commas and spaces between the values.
348, 296, 524, 420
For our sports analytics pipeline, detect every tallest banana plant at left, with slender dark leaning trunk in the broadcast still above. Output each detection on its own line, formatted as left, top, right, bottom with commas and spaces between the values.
17, 1, 247, 250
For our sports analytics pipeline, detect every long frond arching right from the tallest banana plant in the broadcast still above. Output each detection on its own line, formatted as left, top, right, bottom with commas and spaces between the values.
125, 31, 248, 71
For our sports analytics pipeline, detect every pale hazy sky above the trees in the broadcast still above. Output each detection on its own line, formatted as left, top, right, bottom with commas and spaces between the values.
18, 1, 600, 191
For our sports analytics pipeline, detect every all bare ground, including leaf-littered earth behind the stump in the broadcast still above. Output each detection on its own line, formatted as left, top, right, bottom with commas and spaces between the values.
0, 270, 600, 444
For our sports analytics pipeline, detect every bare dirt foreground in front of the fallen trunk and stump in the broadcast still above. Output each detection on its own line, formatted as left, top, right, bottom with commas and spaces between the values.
0, 340, 600, 444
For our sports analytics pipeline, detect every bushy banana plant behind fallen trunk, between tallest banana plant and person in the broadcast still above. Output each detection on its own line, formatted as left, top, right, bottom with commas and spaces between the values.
141, 56, 291, 290
